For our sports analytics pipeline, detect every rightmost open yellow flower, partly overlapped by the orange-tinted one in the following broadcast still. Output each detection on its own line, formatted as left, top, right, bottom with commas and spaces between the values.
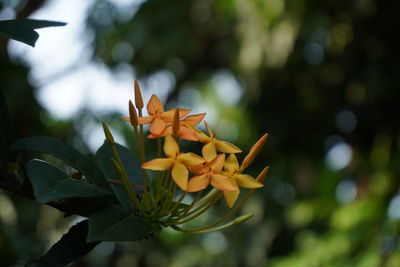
222, 154, 264, 208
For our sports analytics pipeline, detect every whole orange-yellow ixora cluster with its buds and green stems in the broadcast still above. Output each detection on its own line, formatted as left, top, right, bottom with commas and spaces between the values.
103, 81, 268, 233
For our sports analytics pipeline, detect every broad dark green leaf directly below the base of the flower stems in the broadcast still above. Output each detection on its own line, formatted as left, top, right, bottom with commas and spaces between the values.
87, 205, 152, 242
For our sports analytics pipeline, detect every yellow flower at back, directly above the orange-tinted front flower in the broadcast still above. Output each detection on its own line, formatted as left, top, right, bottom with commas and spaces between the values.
187, 122, 242, 161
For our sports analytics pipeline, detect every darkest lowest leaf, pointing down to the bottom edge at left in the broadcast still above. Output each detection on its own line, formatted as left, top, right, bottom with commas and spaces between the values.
28, 220, 100, 267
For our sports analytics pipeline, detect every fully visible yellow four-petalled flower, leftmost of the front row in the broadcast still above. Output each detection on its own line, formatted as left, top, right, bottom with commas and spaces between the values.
142, 135, 204, 191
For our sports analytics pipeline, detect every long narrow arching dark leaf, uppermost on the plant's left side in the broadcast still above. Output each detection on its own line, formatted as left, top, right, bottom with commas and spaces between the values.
12, 136, 110, 190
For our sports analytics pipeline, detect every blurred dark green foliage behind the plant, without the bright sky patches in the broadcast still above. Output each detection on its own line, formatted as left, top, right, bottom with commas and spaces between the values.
0, 0, 400, 267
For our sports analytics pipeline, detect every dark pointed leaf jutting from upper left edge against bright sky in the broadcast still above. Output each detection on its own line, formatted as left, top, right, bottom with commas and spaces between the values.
0, 19, 66, 47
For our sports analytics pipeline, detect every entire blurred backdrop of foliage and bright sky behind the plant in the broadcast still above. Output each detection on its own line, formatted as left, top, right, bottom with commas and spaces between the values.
0, 0, 400, 267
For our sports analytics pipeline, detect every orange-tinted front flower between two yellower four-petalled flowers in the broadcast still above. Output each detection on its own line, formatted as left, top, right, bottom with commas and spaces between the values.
187, 154, 238, 192
